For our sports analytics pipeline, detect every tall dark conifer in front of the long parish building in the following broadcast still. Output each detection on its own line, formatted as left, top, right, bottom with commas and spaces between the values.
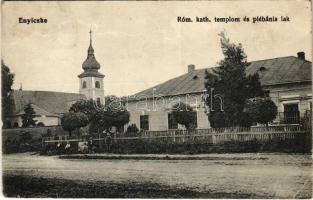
205, 32, 264, 127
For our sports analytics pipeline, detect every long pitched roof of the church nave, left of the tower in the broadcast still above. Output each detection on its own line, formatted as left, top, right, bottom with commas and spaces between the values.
12, 90, 86, 114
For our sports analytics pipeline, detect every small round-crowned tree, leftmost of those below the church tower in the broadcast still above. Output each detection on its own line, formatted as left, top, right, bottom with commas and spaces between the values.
61, 112, 89, 136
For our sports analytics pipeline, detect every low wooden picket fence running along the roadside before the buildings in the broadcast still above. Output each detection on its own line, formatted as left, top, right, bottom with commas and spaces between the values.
42, 125, 311, 144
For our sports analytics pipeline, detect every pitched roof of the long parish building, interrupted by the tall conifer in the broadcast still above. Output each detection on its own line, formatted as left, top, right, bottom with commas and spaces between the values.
133, 56, 312, 99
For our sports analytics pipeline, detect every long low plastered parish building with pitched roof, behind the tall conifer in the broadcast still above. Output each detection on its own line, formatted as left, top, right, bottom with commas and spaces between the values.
127, 52, 312, 131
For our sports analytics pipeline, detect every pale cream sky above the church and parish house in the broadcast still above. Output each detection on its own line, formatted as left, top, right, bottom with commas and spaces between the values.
1, 0, 312, 96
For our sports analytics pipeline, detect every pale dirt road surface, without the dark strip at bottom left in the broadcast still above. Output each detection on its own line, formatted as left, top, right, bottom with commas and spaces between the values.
3, 154, 312, 198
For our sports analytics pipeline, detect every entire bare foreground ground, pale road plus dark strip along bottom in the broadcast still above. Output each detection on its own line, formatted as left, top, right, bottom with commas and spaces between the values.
3, 154, 312, 198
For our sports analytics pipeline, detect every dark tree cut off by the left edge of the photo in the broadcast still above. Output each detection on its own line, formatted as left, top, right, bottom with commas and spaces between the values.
1, 60, 14, 128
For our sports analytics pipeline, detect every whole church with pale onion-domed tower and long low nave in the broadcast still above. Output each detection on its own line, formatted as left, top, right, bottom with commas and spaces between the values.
6, 31, 104, 127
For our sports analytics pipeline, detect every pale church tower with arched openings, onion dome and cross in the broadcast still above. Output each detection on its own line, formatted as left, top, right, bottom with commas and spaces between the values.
78, 30, 104, 104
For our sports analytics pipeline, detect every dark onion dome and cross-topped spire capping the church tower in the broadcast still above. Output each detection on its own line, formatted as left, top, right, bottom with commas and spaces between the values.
78, 31, 104, 78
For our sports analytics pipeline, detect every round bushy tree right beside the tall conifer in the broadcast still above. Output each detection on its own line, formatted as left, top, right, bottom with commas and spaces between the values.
245, 98, 277, 125
